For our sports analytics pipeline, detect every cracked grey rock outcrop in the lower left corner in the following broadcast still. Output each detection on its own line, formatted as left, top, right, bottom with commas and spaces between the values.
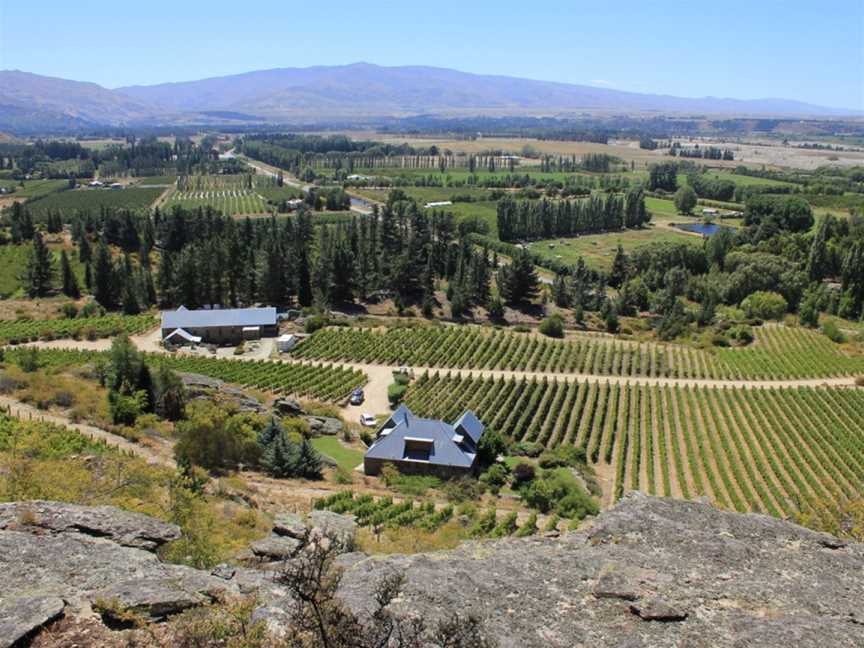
0, 502, 237, 620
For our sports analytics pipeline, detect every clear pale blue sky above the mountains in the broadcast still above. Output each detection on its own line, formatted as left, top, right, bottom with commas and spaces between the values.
0, 0, 864, 109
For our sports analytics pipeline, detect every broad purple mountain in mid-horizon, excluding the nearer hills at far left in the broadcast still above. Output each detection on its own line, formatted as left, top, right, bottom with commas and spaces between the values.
118, 63, 849, 118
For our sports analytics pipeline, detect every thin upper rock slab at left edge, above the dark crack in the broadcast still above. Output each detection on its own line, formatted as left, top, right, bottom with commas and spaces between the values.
0, 500, 180, 551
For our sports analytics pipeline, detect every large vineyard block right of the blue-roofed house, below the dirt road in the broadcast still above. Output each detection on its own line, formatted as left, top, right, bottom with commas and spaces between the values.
406, 372, 864, 528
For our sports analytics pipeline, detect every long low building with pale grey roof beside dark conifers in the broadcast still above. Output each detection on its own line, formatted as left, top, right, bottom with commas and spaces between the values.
162, 306, 278, 344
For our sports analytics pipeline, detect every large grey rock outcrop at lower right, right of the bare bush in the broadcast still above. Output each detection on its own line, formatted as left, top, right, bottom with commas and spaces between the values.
340, 493, 864, 648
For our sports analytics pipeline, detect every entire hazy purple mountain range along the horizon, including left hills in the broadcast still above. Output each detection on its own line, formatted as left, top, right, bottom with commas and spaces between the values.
0, 63, 861, 132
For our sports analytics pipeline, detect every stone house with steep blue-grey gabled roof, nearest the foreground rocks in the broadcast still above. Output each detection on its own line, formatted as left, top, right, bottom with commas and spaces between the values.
363, 405, 485, 478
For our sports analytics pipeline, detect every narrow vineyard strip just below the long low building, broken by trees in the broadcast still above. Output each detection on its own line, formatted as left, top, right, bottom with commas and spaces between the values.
6, 349, 366, 401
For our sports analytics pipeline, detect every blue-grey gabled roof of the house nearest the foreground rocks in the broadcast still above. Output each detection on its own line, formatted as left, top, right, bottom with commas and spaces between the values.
366, 404, 483, 468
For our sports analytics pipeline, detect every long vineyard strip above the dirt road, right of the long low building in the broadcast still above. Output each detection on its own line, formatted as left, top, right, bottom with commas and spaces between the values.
294, 326, 864, 380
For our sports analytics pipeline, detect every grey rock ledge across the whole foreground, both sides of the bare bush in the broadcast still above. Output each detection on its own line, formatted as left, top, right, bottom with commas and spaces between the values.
0, 493, 864, 648
